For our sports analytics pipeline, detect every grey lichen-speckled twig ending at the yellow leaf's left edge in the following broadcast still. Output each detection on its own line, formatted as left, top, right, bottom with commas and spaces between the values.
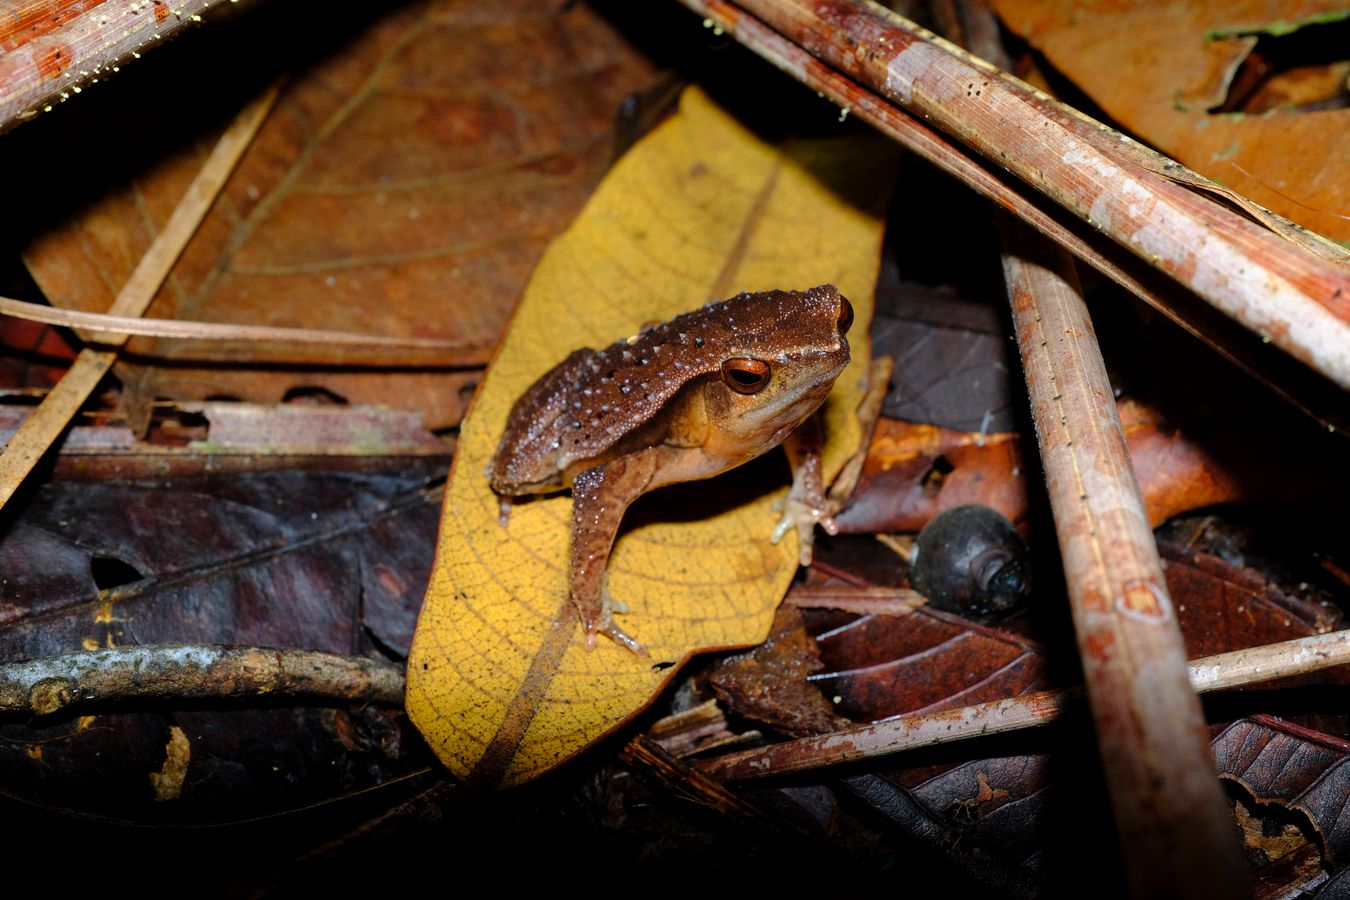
0, 644, 404, 715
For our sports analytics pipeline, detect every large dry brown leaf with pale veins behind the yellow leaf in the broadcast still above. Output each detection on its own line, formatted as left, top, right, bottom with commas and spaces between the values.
12, 0, 651, 428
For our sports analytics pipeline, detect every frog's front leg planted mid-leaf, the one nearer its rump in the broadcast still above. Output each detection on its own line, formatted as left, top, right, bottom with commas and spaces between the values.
570, 448, 659, 656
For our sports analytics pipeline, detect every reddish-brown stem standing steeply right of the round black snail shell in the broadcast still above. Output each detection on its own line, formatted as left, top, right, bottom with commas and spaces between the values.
1003, 228, 1246, 897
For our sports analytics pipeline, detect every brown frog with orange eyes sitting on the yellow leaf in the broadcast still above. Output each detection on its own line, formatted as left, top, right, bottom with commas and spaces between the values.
486, 285, 853, 656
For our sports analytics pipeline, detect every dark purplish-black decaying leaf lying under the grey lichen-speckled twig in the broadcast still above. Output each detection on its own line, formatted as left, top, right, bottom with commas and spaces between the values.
0, 466, 440, 820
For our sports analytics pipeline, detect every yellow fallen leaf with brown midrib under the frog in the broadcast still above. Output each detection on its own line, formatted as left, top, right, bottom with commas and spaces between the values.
408, 89, 895, 785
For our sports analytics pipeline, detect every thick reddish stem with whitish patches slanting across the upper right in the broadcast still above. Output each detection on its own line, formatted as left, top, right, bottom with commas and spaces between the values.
683, 0, 1350, 387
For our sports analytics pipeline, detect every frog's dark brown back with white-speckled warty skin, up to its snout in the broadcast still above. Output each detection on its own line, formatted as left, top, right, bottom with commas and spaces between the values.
489, 285, 838, 495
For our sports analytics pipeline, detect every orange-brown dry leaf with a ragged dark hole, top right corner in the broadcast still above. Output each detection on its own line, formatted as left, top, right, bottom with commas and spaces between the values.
994, 0, 1350, 242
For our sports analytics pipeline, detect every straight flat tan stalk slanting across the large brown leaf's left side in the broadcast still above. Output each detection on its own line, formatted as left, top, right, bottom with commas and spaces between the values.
0, 84, 281, 507
